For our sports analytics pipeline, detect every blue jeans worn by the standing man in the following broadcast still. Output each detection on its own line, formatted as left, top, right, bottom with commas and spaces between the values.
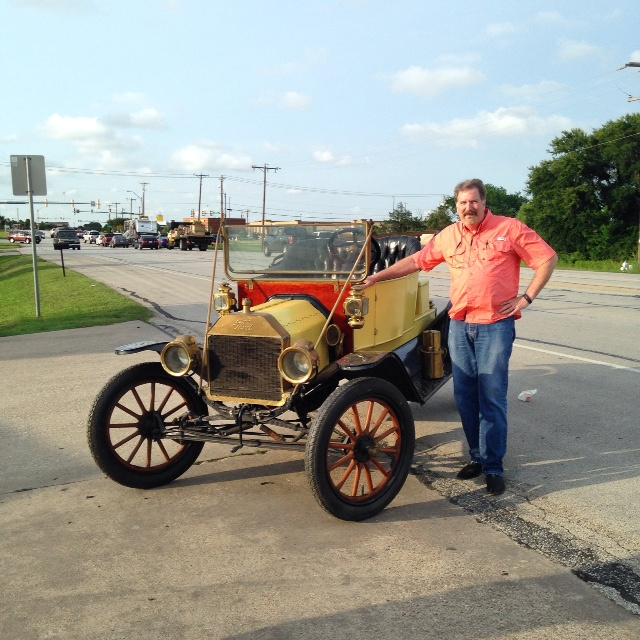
449, 318, 516, 476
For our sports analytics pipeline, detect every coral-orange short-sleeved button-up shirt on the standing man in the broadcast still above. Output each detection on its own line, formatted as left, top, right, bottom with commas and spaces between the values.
413, 209, 555, 324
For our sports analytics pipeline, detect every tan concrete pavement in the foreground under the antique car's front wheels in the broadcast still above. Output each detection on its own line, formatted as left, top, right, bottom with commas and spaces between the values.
0, 323, 640, 640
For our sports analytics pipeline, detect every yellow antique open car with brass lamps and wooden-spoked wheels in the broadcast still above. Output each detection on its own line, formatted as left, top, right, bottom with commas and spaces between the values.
88, 221, 451, 520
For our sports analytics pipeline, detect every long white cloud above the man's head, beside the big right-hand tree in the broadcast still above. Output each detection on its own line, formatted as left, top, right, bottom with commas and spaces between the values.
401, 107, 571, 149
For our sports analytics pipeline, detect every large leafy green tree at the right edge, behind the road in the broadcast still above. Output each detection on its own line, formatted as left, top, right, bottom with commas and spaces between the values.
518, 114, 640, 260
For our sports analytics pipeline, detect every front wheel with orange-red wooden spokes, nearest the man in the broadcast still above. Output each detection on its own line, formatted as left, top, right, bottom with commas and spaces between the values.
305, 378, 415, 521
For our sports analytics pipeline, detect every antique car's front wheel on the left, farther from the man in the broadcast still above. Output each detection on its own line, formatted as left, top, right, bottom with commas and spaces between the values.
87, 362, 207, 489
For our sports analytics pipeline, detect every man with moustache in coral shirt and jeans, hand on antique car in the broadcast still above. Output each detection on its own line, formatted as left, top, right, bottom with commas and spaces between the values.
364, 179, 558, 495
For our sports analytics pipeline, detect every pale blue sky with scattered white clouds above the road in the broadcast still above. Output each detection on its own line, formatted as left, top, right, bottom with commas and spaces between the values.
0, 0, 640, 225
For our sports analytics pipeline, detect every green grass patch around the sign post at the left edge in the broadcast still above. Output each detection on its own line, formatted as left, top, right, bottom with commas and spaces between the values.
0, 251, 153, 337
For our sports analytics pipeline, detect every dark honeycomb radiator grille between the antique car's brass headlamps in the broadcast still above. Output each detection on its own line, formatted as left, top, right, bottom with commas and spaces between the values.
208, 335, 282, 402
